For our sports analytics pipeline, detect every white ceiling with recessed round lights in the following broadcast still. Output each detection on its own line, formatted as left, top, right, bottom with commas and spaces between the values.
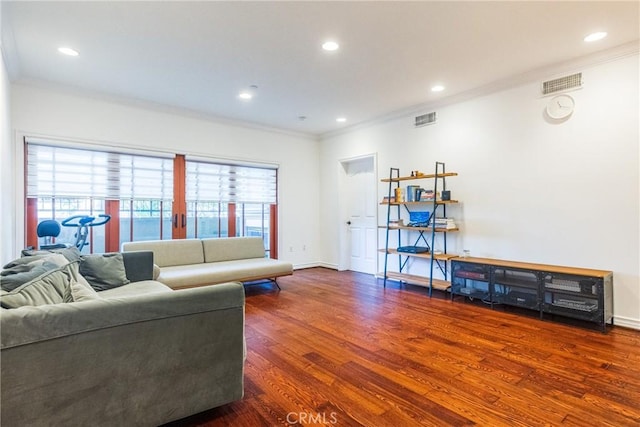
2, 0, 640, 135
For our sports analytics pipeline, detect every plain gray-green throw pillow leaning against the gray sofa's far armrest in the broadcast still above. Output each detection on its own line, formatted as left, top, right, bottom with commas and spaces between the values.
80, 252, 129, 291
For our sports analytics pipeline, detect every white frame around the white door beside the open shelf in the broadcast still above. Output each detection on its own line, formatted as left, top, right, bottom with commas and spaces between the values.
336, 153, 380, 271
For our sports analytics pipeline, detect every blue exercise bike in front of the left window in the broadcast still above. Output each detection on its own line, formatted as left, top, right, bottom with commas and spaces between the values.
36, 214, 111, 251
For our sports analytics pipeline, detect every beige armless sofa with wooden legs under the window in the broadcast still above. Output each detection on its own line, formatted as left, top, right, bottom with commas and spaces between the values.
122, 237, 293, 289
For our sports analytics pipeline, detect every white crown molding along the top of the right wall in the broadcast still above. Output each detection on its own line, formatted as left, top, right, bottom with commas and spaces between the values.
319, 40, 640, 141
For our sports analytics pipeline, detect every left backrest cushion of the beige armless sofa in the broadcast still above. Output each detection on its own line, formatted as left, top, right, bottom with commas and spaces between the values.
122, 239, 204, 267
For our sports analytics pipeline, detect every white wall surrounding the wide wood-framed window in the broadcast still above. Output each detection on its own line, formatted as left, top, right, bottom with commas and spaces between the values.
12, 84, 320, 267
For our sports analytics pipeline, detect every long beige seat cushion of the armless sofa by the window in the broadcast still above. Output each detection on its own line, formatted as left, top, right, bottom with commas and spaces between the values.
158, 258, 293, 289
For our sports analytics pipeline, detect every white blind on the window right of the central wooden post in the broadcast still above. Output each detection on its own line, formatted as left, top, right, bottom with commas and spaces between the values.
186, 160, 278, 204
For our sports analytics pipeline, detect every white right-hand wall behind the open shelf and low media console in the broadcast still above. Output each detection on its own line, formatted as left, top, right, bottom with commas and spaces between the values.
320, 54, 640, 329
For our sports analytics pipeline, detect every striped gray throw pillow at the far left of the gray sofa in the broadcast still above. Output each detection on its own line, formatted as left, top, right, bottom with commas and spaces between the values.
0, 263, 77, 308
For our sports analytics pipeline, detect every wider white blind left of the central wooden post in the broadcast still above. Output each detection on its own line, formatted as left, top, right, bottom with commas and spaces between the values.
27, 142, 173, 201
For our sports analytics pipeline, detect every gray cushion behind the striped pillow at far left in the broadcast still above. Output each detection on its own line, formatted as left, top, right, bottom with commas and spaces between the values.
0, 253, 69, 291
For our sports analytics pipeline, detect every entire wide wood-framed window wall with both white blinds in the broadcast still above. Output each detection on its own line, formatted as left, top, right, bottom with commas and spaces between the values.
25, 138, 278, 258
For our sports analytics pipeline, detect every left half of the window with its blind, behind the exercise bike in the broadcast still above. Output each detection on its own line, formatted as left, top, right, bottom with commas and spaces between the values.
26, 140, 173, 252
